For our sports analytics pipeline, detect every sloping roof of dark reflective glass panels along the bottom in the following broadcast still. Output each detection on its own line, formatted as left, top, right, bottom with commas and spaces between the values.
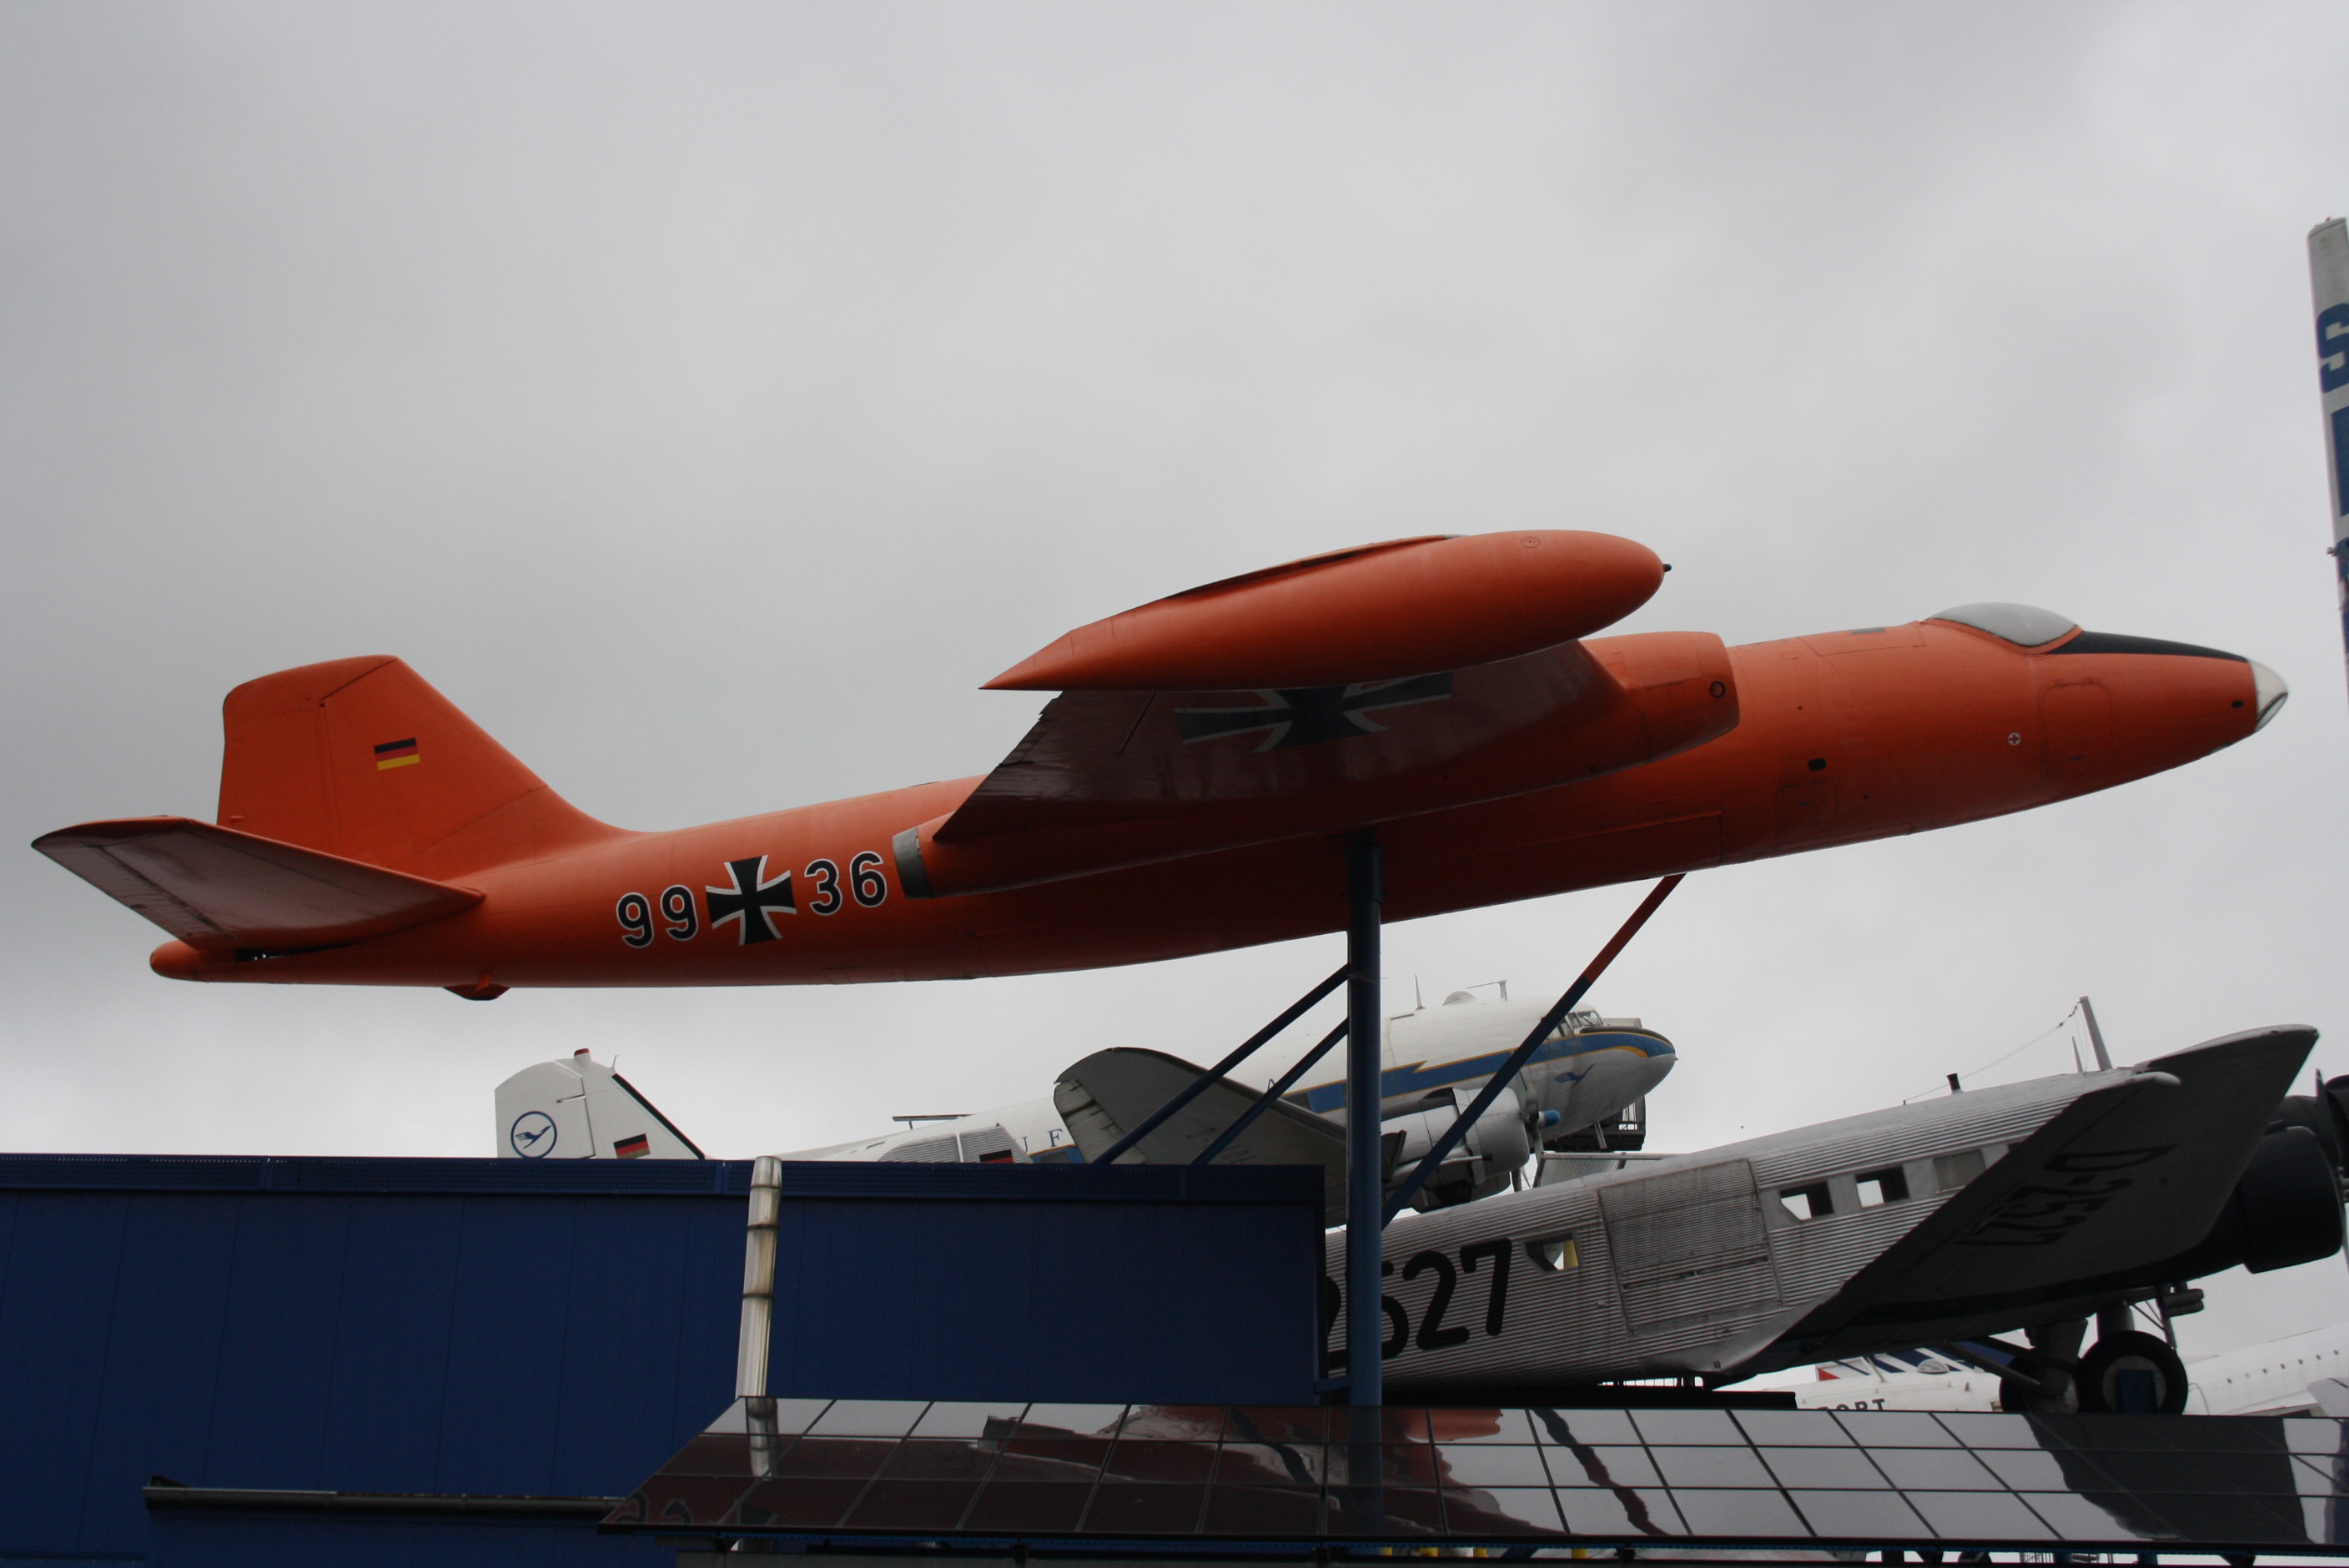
606, 1399, 2349, 1556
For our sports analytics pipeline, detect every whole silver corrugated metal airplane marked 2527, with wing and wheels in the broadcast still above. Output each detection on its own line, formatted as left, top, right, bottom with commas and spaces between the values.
1322, 1028, 2342, 1410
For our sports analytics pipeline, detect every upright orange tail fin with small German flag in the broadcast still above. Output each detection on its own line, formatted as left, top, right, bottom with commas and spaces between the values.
219, 655, 618, 878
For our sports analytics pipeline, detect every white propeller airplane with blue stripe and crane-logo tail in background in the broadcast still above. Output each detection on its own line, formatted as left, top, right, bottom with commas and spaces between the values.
498, 986, 1677, 1207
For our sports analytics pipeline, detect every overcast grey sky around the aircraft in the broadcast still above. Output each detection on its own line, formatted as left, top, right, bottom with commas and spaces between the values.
0, 0, 2349, 1352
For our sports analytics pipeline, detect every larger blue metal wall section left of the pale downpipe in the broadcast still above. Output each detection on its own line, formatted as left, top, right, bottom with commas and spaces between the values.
0, 1157, 749, 1563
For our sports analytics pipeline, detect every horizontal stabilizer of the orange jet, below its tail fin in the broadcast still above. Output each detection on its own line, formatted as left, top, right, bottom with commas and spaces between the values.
33, 817, 481, 953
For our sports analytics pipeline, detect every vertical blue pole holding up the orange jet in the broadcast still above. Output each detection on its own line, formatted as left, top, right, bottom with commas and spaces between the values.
1346, 833, 1386, 1406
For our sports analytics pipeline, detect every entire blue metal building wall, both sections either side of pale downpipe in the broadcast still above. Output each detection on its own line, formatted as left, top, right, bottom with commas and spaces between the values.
0, 1155, 1320, 1568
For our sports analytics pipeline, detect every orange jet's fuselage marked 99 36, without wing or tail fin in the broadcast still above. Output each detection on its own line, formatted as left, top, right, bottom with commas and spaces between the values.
153, 622, 2260, 991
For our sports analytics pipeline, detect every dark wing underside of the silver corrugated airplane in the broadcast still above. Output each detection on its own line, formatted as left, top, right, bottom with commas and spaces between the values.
1785, 1026, 2316, 1354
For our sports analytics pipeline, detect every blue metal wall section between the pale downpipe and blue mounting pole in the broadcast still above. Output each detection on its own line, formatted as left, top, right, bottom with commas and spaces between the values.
768, 1162, 1322, 1404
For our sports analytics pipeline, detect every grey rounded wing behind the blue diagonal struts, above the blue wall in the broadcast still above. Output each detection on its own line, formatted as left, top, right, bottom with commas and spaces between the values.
1053, 1047, 1346, 1225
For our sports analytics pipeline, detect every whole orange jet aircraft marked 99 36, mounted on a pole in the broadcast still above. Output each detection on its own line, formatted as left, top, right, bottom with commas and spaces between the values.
35, 533, 2286, 1000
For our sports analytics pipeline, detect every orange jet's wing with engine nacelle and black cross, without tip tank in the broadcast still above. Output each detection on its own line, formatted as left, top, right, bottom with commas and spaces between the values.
895, 631, 1736, 897
